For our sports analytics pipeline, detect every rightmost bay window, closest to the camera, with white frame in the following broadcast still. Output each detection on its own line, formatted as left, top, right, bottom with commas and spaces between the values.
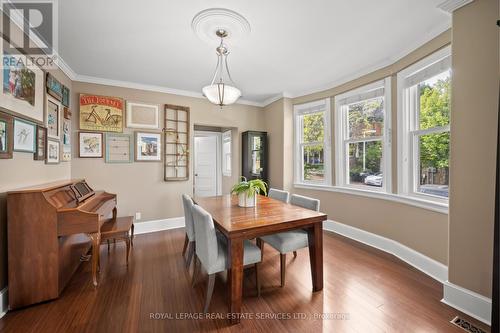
398, 48, 451, 201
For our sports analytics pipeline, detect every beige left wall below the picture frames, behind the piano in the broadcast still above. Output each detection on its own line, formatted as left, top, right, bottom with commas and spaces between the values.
0, 70, 72, 290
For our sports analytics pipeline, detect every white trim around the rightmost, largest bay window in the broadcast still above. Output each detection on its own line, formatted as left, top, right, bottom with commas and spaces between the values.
397, 46, 451, 207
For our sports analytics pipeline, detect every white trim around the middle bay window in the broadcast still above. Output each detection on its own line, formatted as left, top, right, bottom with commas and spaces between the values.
335, 77, 392, 193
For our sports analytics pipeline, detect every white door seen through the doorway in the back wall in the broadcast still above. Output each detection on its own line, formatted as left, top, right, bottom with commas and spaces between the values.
194, 133, 220, 197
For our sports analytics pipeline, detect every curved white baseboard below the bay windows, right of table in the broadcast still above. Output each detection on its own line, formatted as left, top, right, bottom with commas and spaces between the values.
323, 220, 448, 283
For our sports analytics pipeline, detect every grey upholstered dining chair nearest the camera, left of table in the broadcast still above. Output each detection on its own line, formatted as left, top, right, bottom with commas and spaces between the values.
192, 205, 261, 313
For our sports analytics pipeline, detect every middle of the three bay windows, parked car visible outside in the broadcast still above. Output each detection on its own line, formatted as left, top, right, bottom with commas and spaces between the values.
335, 78, 391, 191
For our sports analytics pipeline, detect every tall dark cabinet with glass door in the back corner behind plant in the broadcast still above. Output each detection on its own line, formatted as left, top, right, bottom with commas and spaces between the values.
242, 131, 268, 182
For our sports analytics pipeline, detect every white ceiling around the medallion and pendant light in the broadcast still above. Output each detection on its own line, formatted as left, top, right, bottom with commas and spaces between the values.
59, 0, 451, 104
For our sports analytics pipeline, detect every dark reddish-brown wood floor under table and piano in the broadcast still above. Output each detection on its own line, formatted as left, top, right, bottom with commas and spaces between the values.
0, 229, 489, 333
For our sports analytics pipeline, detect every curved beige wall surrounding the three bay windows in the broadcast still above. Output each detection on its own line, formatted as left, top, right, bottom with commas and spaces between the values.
266, 31, 451, 264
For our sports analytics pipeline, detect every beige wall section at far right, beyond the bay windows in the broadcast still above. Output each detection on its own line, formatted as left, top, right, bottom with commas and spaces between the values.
449, 0, 500, 297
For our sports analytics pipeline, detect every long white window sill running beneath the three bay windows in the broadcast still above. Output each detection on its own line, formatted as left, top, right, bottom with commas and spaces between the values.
293, 183, 448, 215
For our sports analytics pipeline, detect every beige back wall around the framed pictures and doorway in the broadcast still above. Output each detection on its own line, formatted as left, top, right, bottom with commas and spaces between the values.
71, 82, 265, 221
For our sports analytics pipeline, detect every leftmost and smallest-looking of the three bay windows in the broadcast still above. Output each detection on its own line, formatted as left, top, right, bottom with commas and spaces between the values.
294, 99, 331, 185
